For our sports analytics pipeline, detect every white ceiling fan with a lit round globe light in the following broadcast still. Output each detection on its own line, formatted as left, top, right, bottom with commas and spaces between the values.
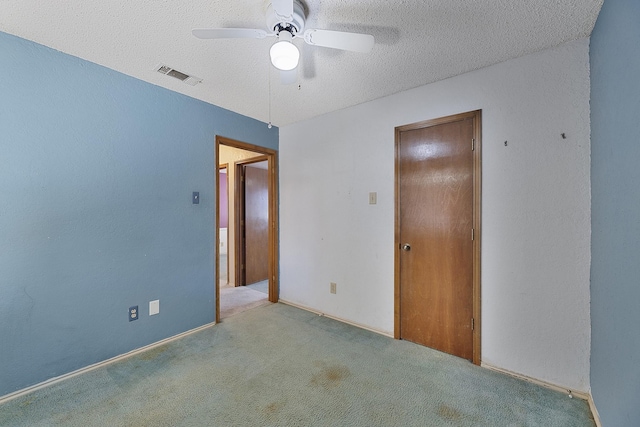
192, 0, 374, 72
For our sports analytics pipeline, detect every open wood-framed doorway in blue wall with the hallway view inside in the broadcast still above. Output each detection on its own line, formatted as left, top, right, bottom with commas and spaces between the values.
215, 136, 279, 322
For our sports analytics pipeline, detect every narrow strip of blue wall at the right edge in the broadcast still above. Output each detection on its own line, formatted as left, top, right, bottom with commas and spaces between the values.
591, 0, 640, 427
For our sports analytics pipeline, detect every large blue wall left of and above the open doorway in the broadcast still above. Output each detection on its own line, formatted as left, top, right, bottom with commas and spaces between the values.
0, 33, 278, 396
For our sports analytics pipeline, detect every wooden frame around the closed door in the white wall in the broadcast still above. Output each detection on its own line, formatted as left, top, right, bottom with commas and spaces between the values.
393, 110, 482, 365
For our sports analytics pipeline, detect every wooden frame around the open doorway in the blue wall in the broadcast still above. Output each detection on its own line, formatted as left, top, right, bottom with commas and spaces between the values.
214, 135, 279, 323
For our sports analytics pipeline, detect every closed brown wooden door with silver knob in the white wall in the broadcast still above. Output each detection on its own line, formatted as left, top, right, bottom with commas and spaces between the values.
397, 115, 474, 360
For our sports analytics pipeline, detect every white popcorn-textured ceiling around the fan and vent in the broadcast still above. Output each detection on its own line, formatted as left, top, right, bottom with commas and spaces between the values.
0, 0, 603, 126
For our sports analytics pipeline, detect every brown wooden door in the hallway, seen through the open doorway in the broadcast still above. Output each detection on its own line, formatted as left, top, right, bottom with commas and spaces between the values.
244, 166, 269, 285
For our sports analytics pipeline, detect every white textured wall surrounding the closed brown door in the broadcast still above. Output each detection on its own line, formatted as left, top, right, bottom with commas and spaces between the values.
280, 39, 590, 391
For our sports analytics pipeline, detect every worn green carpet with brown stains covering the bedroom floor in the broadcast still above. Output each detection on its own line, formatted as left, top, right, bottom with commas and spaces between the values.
0, 304, 595, 427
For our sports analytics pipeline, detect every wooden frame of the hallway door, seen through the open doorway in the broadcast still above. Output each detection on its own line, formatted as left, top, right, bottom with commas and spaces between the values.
233, 155, 271, 286
